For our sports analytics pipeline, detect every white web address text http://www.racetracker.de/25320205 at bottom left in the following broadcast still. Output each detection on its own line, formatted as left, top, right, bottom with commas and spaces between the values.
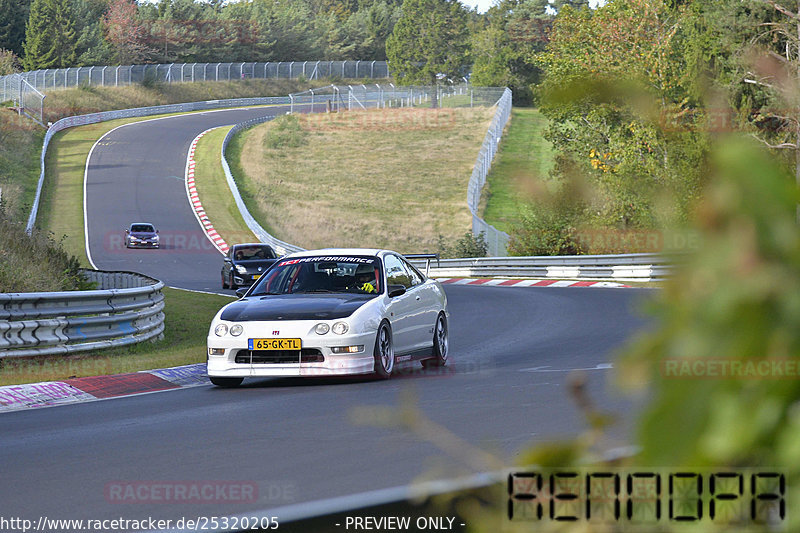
0, 516, 279, 533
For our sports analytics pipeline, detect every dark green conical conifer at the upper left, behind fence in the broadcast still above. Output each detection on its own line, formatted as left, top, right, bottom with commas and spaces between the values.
23, 0, 77, 70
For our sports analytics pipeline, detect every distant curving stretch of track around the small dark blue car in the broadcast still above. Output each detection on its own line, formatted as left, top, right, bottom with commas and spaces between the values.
84, 106, 300, 291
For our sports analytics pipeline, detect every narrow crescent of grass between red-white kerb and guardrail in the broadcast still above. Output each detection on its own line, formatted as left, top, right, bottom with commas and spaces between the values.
194, 126, 258, 245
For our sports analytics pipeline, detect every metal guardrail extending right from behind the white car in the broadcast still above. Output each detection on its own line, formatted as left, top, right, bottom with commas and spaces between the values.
411, 254, 679, 281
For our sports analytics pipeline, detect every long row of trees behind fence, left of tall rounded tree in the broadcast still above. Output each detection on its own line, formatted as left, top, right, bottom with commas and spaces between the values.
0, 0, 402, 70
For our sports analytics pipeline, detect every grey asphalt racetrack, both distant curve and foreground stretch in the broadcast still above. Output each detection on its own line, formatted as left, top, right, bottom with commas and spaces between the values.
0, 105, 648, 522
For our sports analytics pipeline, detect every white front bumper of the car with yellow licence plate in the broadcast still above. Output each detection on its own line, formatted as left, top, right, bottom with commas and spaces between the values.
206, 322, 377, 378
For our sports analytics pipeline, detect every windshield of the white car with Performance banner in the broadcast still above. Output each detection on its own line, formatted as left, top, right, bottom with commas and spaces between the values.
249, 256, 383, 296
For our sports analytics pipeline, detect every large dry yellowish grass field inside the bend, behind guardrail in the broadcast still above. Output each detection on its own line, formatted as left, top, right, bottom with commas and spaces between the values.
230, 107, 494, 253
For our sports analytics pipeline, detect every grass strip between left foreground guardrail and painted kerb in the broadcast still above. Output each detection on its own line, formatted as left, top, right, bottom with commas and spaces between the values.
0, 288, 231, 386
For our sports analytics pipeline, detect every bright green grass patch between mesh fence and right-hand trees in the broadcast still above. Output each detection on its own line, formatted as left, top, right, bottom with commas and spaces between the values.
483, 107, 554, 232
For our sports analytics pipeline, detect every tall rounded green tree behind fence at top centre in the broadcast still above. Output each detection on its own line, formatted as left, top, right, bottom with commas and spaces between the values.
386, 0, 469, 92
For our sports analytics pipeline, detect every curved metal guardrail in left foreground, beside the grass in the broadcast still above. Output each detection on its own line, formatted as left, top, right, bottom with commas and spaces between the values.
0, 270, 164, 359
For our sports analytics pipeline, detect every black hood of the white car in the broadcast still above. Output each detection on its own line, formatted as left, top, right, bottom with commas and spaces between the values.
220, 294, 374, 322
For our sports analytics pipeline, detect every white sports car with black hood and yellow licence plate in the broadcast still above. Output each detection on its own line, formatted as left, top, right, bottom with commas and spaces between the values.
208, 249, 449, 387
